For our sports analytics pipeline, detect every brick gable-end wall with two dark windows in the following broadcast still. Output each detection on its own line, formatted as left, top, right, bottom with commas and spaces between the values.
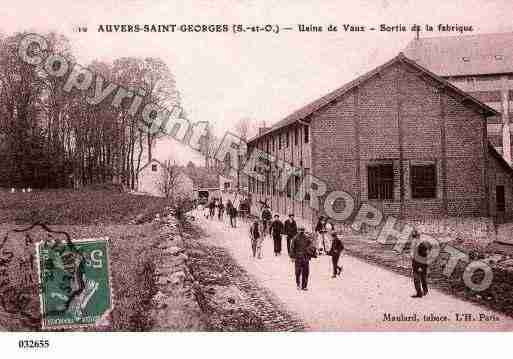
311, 65, 486, 222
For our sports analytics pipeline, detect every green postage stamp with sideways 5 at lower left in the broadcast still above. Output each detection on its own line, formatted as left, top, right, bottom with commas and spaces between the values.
36, 237, 112, 329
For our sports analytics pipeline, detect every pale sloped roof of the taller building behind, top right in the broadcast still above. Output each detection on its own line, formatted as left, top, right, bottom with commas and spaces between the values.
404, 32, 513, 77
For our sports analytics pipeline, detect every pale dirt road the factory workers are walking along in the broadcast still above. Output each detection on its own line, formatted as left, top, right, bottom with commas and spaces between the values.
197, 213, 513, 331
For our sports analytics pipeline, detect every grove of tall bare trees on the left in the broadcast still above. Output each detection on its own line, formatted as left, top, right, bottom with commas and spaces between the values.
0, 33, 180, 188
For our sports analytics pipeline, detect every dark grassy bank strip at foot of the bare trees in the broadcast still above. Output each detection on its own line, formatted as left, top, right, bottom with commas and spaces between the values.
0, 190, 169, 225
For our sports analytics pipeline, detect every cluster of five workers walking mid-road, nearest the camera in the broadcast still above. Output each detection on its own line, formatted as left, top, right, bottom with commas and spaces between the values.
249, 206, 344, 290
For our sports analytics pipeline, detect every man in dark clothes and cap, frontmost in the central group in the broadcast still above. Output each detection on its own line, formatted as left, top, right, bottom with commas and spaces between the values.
290, 227, 315, 290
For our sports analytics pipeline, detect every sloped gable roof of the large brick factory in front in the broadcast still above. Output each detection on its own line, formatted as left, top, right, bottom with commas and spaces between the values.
248, 52, 498, 143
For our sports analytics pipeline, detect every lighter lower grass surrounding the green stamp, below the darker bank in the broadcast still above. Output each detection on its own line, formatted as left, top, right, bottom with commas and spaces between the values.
0, 223, 160, 331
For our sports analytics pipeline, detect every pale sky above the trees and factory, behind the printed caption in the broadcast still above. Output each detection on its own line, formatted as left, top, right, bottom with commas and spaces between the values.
0, 0, 513, 162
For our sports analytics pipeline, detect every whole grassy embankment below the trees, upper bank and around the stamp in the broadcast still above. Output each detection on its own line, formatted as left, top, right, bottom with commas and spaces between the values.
0, 190, 174, 331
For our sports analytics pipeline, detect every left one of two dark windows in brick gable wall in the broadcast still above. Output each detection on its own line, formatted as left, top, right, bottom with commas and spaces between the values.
367, 163, 394, 200
